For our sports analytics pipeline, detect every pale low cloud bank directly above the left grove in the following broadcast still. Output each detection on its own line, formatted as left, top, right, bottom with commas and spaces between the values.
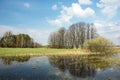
0, 25, 50, 44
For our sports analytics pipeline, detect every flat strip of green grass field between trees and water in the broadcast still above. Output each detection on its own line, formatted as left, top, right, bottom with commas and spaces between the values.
0, 48, 88, 56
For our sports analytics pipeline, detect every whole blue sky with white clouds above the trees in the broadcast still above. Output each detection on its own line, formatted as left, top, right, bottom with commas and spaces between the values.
0, 0, 120, 45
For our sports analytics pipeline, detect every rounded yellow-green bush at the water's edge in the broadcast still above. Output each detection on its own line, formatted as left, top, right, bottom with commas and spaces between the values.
86, 37, 113, 53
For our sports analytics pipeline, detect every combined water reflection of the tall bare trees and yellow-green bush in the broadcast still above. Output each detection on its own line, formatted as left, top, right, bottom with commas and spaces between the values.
49, 54, 117, 77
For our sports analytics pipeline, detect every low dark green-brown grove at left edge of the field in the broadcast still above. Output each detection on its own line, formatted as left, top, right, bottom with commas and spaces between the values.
0, 31, 41, 48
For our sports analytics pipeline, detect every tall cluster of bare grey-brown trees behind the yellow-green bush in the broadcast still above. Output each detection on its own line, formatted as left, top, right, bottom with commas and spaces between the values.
48, 22, 99, 48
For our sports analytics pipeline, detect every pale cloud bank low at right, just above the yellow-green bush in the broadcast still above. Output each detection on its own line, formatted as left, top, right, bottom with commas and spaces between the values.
94, 21, 120, 45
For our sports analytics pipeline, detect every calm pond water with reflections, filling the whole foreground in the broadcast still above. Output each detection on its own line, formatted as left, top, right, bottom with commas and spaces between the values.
0, 54, 120, 80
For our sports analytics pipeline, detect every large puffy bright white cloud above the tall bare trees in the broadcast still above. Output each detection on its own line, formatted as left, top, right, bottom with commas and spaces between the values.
48, 0, 95, 26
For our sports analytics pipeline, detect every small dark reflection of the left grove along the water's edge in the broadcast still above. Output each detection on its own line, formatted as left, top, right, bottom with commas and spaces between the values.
1, 56, 30, 65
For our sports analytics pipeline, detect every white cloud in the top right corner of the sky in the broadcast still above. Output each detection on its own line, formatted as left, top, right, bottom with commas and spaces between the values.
97, 0, 120, 18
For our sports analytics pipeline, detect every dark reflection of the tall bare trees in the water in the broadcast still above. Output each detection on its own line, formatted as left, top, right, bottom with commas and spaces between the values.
49, 56, 96, 77
